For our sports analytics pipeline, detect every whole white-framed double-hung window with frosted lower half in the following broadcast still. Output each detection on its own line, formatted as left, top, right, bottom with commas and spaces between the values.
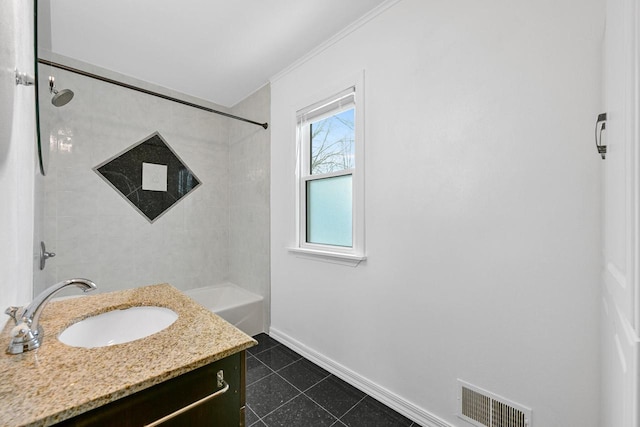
291, 78, 364, 264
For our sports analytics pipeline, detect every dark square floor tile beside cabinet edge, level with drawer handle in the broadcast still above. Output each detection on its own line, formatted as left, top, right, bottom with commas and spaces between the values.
247, 374, 300, 418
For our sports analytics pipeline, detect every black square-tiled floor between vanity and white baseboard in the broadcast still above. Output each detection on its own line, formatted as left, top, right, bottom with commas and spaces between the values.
246, 334, 419, 427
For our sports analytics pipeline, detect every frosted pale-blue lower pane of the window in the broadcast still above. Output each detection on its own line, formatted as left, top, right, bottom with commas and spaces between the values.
307, 175, 353, 247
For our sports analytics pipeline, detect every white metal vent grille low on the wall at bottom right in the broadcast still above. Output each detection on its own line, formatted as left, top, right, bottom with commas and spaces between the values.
458, 380, 532, 427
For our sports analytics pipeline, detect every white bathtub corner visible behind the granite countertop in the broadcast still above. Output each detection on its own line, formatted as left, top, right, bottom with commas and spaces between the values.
184, 283, 264, 336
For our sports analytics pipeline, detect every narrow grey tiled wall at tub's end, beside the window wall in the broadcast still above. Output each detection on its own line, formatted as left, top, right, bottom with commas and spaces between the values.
229, 85, 271, 325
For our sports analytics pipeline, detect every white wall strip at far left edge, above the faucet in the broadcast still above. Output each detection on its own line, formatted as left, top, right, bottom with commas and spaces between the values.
0, 2, 36, 311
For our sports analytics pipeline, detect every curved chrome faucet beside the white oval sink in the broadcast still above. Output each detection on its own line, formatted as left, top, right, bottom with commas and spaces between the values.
5, 279, 97, 354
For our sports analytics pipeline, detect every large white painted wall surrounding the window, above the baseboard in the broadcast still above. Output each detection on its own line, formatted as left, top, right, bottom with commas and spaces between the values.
271, 0, 604, 427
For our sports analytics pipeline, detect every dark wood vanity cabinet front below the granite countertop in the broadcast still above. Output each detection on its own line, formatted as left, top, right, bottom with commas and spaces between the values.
57, 351, 246, 427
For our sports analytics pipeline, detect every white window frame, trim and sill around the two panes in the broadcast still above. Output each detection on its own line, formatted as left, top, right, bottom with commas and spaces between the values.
289, 73, 366, 266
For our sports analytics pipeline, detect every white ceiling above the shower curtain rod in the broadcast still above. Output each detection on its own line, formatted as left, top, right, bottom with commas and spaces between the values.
45, 0, 387, 107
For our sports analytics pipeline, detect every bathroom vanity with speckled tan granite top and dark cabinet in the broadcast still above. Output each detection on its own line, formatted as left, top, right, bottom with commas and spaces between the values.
0, 284, 256, 427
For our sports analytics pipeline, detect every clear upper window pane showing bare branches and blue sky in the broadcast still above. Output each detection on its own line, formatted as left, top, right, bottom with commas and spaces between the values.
310, 108, 355, 175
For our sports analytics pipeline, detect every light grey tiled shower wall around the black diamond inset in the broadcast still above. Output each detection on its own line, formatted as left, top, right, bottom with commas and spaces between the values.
41, 67, 229, 292
